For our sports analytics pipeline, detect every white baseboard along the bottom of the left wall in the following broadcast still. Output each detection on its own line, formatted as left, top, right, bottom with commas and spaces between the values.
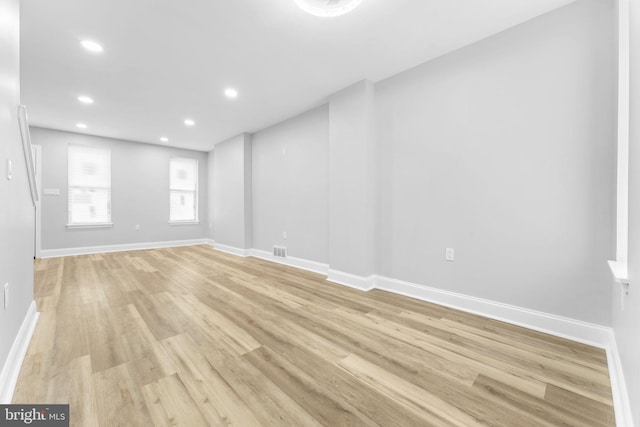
0, 301, 40, 405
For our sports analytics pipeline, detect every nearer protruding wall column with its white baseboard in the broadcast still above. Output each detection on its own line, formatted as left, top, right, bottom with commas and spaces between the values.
328, 81, 376, 289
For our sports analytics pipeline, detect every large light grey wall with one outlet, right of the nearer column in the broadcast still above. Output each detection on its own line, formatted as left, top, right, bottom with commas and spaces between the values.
376, 0, 615, 325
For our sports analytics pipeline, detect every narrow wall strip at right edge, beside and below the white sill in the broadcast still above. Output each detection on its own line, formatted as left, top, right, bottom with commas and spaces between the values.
612, 1, 640, 426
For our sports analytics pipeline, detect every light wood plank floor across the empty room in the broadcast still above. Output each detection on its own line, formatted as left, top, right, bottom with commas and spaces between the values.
14, 246, 614, 427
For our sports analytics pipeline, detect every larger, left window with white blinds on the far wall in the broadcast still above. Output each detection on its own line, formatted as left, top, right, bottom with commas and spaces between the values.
68, 145, 112, 226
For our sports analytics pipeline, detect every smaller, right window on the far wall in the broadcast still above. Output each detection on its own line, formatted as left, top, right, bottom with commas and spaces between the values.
169, 157, 198, 222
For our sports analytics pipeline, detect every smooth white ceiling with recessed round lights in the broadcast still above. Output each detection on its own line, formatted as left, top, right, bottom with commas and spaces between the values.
21, 0, 574, 151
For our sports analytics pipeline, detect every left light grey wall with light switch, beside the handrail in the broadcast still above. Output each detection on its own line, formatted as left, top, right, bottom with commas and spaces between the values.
0, 0, 35, 392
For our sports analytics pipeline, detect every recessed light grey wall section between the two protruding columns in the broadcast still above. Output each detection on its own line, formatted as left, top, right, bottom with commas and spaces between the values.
252, 105, 329, 263
